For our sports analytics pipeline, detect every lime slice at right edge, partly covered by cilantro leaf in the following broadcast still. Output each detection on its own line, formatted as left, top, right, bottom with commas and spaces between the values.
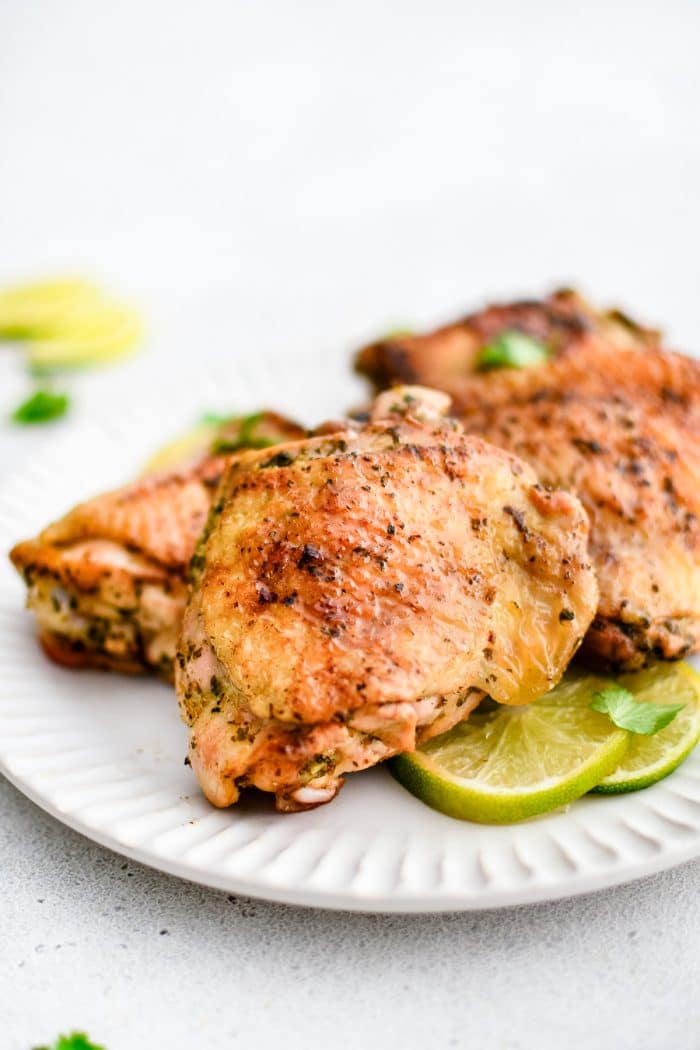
594, 664, 700, 795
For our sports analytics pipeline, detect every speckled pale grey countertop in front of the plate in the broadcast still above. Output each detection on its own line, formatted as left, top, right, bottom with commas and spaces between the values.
5, 783, 700, 1050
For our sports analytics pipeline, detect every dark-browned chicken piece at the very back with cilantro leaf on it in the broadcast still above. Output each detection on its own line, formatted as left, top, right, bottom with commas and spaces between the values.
356, 289, 660, 394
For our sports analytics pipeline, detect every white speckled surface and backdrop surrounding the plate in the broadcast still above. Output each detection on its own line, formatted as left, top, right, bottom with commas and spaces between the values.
0, 0, 700, 1050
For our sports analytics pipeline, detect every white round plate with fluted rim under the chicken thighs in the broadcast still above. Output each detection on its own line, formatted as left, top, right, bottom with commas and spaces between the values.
0, 360, 700, 911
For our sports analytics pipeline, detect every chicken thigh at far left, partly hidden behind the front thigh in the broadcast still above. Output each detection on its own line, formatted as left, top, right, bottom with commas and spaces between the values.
10, 413, 305, 677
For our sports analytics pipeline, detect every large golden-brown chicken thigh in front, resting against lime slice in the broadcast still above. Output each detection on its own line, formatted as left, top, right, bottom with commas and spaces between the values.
175, 390, 597, 811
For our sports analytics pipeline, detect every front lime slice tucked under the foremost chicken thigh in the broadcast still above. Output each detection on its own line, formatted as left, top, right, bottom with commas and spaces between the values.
389, 671, 630, 824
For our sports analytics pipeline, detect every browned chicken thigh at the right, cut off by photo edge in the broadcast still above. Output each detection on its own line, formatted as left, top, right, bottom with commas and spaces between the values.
359, 296, 700, 671
